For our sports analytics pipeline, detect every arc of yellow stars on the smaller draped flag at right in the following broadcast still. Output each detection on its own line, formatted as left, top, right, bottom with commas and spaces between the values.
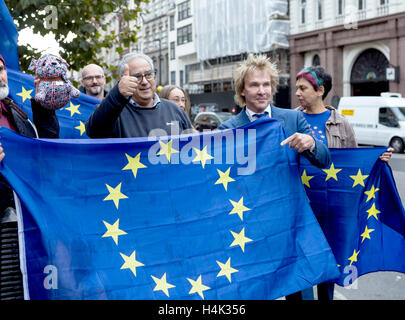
301, 163, 381, 276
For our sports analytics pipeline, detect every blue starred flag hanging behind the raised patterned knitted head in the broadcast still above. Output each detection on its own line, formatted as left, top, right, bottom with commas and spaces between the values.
7, 69, 100, 139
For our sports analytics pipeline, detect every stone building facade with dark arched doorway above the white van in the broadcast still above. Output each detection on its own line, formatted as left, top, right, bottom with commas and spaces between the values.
288, 0, 405, 107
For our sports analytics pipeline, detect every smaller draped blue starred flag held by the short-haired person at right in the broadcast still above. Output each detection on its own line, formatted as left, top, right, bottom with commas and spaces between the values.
301, 148, 405, 286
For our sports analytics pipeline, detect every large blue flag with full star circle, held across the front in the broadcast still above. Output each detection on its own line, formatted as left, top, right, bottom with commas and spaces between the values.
0, 119, 338, 300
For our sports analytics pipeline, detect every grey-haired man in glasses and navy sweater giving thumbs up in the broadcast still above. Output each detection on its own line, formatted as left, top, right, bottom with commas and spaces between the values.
86, 53, 192, 138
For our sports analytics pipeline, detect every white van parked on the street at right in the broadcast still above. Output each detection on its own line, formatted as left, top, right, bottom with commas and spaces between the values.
338, 92, 405, 152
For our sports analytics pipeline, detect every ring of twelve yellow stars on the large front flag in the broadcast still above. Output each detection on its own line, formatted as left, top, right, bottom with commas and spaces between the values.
98, 140, 253, 299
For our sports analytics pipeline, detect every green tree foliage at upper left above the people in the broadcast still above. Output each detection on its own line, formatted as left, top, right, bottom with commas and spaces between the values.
6, 0, 149, 80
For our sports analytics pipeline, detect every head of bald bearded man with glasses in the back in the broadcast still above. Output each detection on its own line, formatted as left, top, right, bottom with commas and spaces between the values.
79, 64, 107, 100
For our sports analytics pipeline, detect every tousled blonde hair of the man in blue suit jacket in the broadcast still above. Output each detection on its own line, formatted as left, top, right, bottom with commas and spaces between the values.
233, 53, 279, 107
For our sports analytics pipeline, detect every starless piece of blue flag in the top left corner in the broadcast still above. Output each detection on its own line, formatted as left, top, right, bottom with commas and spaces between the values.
0, 0, 20, 70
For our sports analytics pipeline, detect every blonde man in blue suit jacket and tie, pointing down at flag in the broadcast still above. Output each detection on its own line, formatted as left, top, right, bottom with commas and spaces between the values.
218, 54, 330, 168
